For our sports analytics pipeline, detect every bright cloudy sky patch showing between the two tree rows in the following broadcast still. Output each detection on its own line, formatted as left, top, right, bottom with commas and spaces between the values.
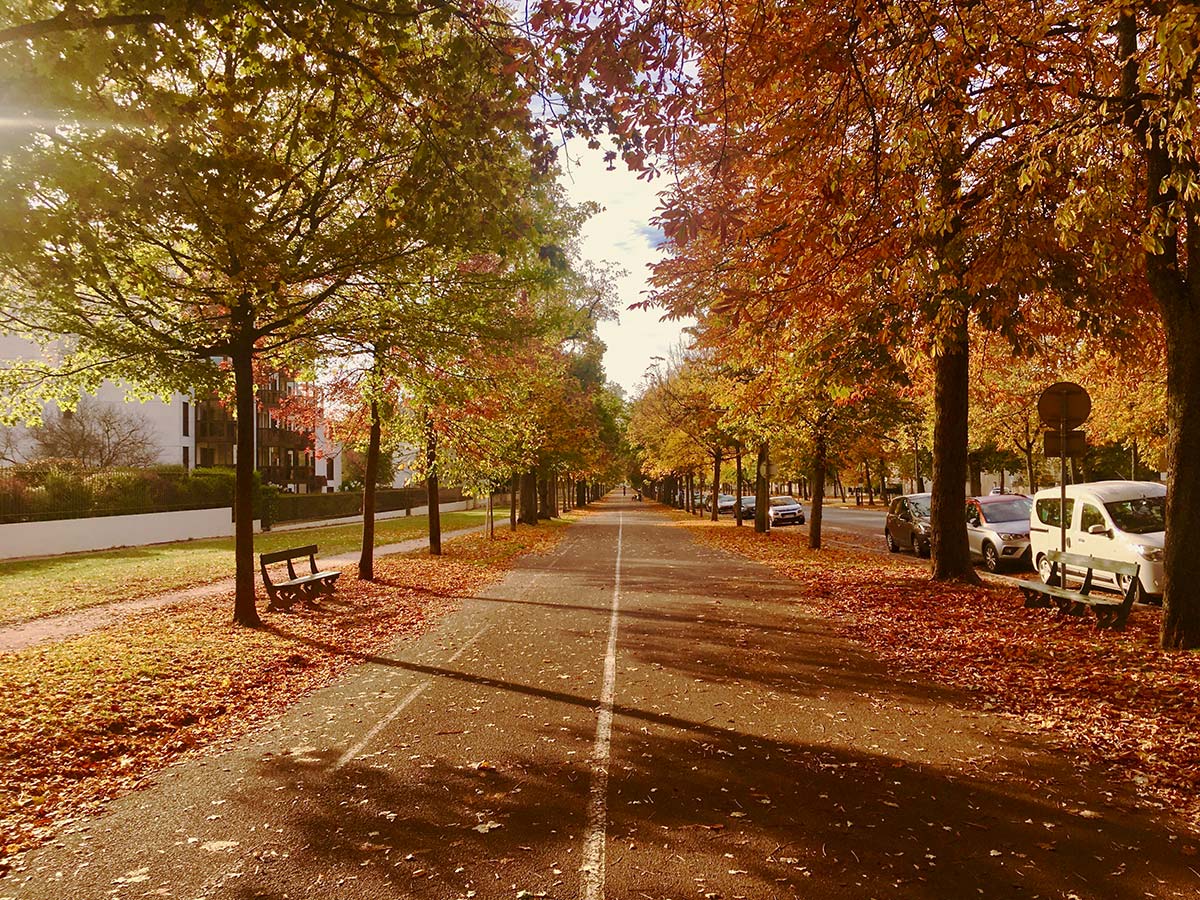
563, 149, 688, 397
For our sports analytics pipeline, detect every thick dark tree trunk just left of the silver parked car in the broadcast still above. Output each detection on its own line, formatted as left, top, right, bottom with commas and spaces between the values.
929, 324, 979, 584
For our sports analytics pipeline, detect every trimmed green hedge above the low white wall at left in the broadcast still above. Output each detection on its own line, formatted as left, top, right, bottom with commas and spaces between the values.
0, 460, 234, 523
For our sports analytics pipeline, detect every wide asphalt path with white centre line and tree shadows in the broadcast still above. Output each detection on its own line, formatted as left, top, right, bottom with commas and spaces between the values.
0, 498, 1200, 900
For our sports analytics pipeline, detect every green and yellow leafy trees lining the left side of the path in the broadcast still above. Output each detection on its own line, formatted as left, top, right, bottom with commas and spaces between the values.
0, 0, 628, 625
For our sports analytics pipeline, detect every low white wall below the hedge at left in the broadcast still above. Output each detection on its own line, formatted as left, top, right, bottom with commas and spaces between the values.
0, 506, 259, 559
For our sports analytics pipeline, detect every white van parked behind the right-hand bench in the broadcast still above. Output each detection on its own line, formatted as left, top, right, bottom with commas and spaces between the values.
1030, 481, 1166, 602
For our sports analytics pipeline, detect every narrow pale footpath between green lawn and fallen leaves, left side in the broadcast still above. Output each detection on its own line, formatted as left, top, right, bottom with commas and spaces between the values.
0, 524, 487, 653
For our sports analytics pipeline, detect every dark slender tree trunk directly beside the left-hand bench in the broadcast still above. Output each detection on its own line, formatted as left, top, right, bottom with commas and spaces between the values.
230, 347, 263, 628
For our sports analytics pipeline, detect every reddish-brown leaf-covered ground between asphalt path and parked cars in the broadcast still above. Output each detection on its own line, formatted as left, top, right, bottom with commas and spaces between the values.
682, 520, 1200, 827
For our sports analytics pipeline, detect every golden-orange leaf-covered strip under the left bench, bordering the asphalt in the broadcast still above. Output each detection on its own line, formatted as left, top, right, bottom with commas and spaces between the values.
0, 522, 563, 871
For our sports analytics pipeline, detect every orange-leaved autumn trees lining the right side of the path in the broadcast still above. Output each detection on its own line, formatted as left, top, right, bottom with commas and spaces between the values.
530, 0, 1200, 648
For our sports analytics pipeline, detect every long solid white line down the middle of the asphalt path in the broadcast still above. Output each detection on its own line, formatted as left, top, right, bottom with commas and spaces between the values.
580, 512, 625, 900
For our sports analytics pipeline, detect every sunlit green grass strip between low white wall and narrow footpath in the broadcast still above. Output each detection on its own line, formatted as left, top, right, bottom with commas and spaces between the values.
0, 509, 508, 625
